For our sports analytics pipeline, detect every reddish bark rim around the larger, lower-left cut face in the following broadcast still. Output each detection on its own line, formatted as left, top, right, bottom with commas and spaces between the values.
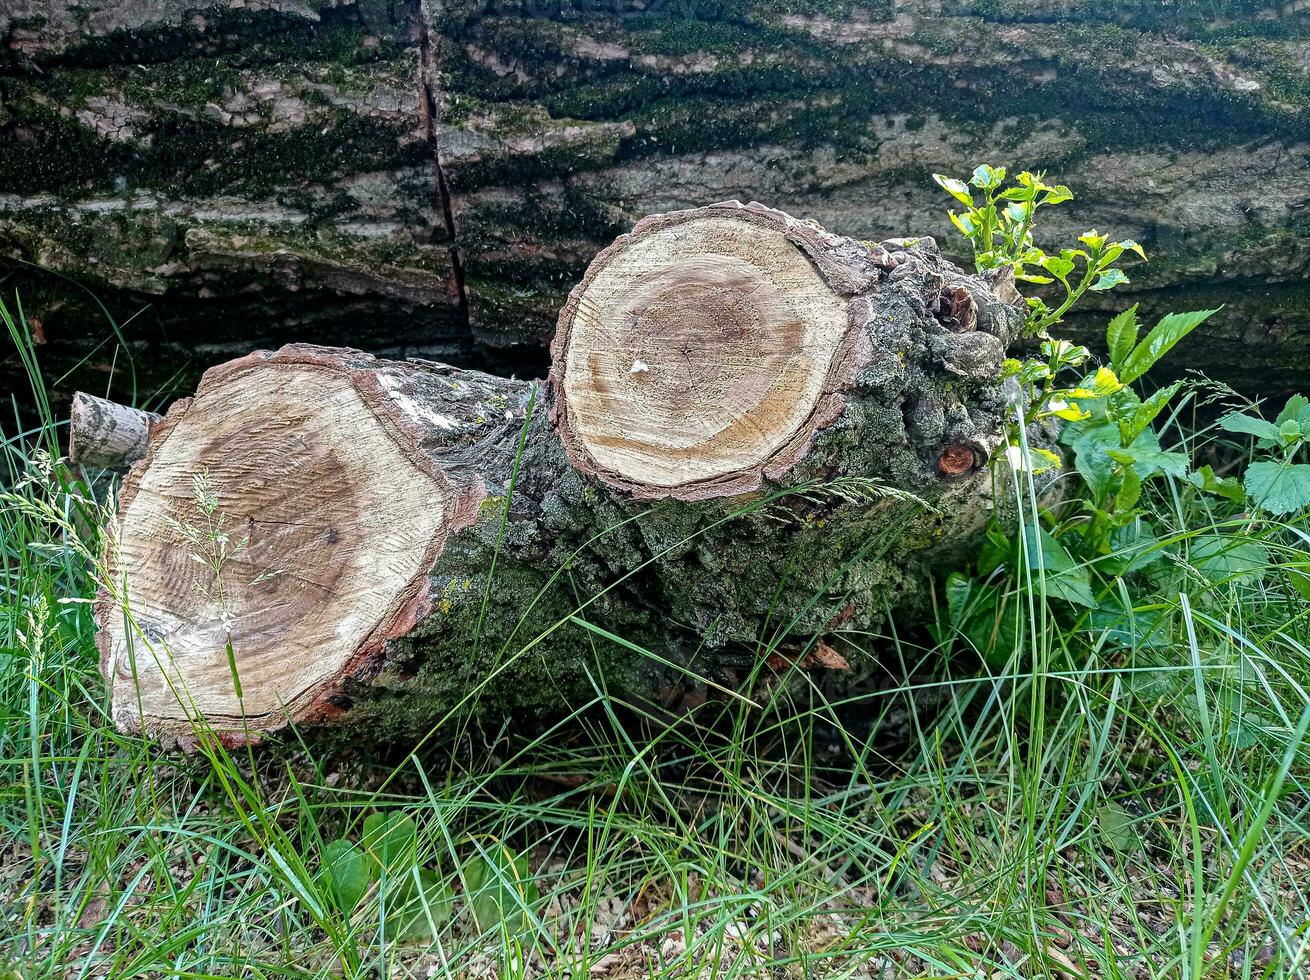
93, 343, 486, 751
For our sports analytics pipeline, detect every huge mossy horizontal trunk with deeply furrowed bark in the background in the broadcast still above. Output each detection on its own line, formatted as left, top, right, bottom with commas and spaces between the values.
0, 0, 1310, 403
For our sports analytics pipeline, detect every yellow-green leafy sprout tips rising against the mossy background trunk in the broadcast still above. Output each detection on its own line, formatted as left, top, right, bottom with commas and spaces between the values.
933, 164, 1146, 337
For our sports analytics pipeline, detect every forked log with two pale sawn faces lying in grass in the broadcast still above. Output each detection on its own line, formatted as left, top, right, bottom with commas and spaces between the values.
98, 203, 1023, 742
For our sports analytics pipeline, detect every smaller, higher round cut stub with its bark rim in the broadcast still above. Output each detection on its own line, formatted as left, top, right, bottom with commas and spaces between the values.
552, 202, 871, 499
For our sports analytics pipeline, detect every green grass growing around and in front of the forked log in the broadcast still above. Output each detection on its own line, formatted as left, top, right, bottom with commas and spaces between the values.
0, 300, 1310, 979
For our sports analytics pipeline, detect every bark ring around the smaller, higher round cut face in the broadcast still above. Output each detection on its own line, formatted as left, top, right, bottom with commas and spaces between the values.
546, 200, 878, 500
